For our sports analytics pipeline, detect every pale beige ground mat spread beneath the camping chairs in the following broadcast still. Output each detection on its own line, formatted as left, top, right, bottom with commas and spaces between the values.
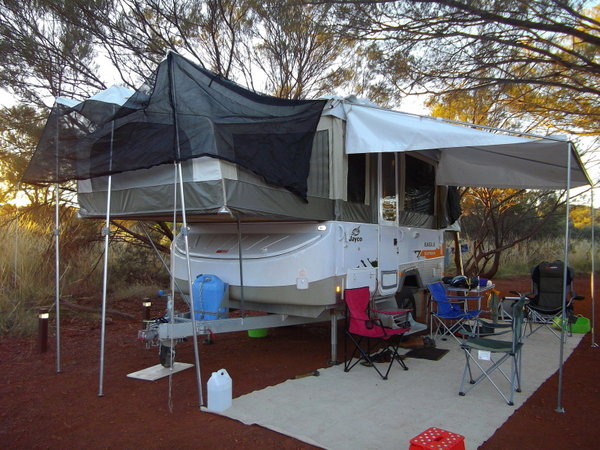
221, 329, 583, 450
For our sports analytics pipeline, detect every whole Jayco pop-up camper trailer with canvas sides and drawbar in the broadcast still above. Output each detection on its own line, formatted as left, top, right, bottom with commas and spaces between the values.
78, 98, 458, 360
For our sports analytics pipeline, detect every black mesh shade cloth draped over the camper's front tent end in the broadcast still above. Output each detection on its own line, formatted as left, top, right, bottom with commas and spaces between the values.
23, 52, 325, 198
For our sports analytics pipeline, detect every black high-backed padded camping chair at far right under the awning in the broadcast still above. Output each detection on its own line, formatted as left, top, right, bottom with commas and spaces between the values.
525, 261, 583, 339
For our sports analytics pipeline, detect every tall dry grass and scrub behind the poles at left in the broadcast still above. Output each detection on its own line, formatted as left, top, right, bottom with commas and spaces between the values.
0, 216, 168, 335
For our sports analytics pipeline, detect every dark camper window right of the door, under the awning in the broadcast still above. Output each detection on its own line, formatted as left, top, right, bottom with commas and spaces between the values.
404, 155, 435, 215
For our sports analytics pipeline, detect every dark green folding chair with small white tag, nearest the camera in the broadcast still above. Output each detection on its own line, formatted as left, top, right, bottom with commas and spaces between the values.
458, 293, 526, 406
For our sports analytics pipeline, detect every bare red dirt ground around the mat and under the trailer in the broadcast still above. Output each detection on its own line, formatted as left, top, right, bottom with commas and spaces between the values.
0, 277, 600, 449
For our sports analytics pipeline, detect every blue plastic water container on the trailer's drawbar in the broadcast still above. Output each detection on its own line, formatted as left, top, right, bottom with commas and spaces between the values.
192, 274, 227, 320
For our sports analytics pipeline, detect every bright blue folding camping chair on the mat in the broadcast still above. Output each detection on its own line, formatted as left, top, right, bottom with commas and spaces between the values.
427, 281, 481, 344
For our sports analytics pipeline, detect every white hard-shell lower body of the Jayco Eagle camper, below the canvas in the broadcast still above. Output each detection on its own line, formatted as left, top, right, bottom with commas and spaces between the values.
174, 221, 443, 317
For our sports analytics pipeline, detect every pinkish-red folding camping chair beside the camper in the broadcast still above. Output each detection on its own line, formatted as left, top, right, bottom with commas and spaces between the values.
344, 287, 410, 380
